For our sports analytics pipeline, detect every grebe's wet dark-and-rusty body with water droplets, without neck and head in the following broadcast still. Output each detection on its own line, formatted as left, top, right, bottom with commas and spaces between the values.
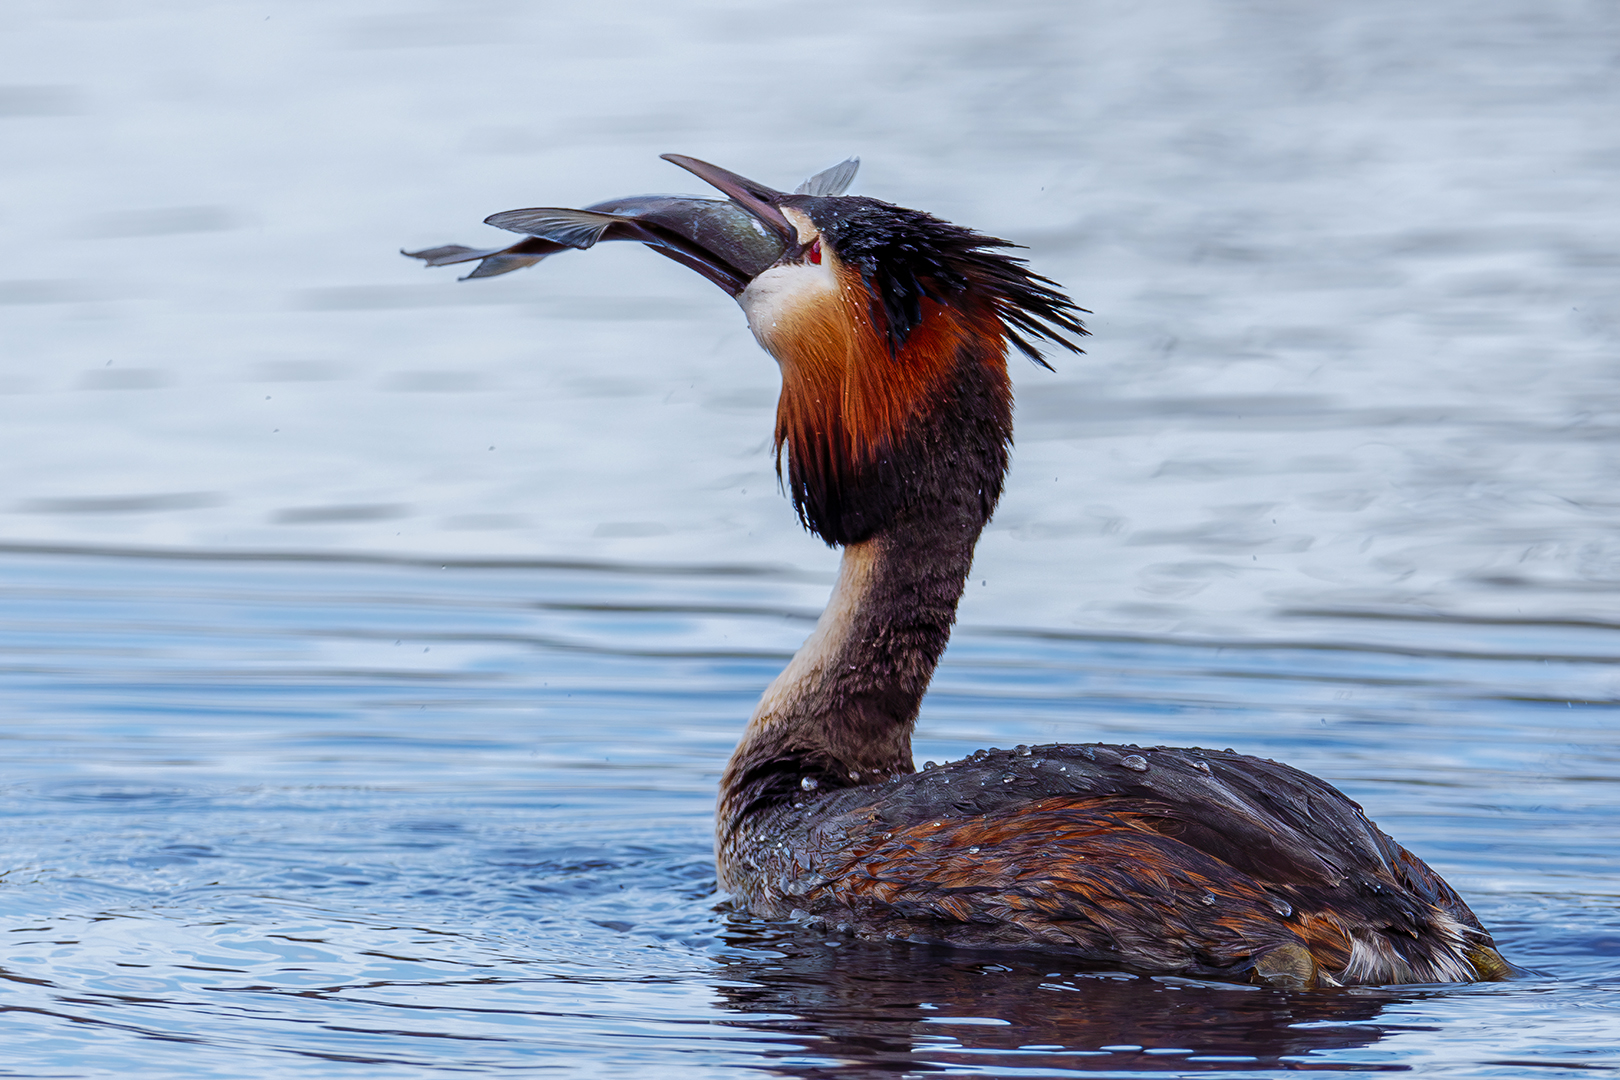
732, 745, 1503, 984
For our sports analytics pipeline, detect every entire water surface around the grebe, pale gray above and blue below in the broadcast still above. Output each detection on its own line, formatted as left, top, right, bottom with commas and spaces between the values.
0, 0, 1620, 1077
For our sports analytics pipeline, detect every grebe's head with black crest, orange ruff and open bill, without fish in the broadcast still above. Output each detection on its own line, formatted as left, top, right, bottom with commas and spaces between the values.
664, 154, 1085, 546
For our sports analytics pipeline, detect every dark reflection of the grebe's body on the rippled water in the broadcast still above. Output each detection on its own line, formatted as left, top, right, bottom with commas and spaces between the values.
719, 928, 1406, 1077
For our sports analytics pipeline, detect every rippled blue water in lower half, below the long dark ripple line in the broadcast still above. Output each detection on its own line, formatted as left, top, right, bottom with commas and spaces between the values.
0, 552, 1620, 1077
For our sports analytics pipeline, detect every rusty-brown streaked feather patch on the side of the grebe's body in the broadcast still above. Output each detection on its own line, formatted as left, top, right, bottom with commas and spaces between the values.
802, 798, 1315, 972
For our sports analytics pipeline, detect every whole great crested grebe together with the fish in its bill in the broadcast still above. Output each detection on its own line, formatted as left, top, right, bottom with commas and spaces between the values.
408, 154, 1510, 988
